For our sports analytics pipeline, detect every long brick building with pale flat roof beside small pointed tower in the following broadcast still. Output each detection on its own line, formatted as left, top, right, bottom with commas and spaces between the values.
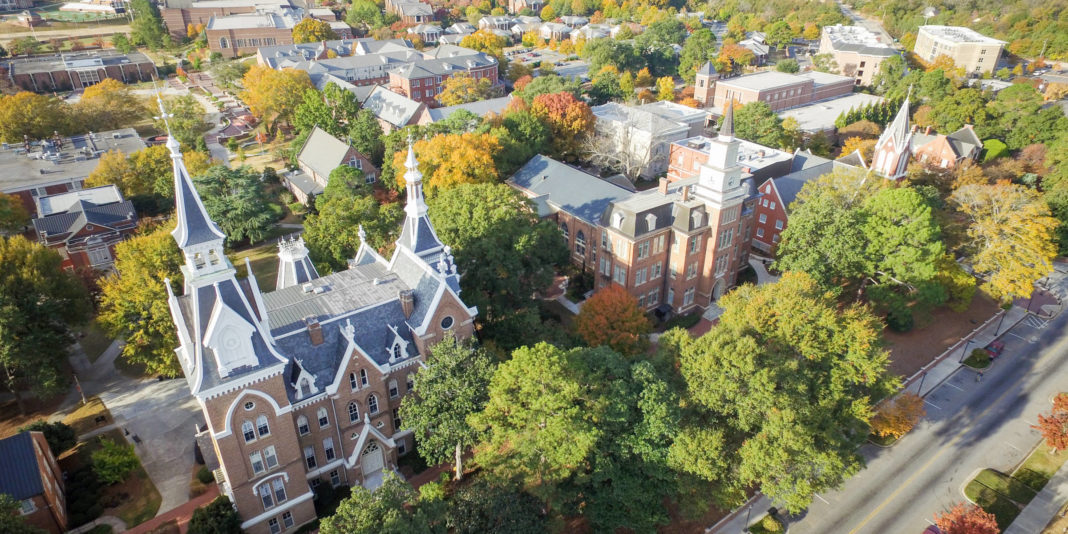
711, 70, 853, 111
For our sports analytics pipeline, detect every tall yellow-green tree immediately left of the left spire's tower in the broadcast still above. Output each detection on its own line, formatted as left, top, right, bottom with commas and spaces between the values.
97, 226, 184, 377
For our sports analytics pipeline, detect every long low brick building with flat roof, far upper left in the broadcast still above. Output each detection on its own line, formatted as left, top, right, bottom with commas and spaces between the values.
0, 50, 158, 93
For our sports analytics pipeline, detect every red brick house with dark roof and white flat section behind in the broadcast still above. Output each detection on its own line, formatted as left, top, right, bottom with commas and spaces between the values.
33, 186, 138, 271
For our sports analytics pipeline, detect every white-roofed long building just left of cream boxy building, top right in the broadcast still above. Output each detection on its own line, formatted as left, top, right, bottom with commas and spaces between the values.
818, 25, 897, 85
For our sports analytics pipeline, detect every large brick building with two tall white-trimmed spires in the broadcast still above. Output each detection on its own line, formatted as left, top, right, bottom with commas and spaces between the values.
168, 119, 477, 534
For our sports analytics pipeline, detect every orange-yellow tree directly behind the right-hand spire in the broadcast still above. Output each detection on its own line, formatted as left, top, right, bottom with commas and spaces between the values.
393, 134, 501, 195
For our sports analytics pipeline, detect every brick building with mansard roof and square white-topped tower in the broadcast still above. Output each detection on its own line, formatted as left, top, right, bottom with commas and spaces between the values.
508, 111, 758, 316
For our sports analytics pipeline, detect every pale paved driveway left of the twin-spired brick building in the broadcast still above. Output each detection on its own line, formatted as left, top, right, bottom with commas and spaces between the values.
70, 342, 203, 515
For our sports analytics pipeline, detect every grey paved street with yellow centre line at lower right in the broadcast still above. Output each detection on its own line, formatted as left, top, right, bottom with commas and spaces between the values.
717, 271, 1068, 534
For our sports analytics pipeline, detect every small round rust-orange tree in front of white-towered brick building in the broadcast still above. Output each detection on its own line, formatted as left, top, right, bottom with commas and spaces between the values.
575, 284, 653, 356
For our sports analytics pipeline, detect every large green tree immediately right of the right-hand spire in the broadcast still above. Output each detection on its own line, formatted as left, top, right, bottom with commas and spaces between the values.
429, 184, 567, 323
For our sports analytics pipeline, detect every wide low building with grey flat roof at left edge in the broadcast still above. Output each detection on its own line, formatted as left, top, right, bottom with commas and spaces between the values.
0, 128, 145, 217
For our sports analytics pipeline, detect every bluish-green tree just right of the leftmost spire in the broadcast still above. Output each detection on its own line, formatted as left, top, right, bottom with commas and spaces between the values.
193, 166, 274, 242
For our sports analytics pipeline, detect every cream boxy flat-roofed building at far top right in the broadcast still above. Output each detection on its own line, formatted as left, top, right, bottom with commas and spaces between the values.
912, 26, 1005, 74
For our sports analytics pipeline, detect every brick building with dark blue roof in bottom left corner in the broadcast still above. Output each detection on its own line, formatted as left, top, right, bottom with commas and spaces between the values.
0, 431, 67, 534
